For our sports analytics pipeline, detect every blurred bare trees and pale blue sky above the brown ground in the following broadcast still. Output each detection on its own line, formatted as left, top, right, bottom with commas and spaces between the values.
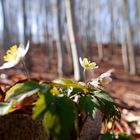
0, 0, 140, 80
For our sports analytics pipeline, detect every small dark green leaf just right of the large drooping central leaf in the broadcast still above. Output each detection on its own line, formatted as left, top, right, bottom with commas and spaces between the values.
79, 96, 99, 119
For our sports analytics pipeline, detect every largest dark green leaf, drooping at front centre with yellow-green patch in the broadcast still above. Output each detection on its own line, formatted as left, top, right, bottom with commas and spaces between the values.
43, 96, 78, 140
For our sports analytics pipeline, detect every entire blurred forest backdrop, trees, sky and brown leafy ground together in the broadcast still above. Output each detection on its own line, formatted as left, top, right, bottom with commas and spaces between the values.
0, 0, 140, 138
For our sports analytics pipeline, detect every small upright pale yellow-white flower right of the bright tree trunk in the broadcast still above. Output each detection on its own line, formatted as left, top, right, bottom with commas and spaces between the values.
79, 57, 98, 70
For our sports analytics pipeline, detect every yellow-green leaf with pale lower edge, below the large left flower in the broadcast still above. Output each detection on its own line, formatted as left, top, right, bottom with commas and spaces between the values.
5, 81, 42, 101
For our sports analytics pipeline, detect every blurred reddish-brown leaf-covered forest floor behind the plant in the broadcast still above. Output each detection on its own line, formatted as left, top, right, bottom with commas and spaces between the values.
0, 43, 140, 139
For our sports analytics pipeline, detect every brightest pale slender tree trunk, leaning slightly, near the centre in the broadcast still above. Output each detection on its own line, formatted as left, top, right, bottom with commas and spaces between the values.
66, 0, 81, 81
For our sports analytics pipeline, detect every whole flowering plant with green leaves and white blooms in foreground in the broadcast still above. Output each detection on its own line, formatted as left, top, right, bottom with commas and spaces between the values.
0, 42, 120, 140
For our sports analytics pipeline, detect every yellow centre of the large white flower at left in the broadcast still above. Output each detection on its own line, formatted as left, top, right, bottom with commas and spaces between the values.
4, 45, 18, 62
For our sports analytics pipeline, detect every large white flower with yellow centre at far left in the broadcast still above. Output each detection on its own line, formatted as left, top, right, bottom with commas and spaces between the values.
0, 41, 29, 70
